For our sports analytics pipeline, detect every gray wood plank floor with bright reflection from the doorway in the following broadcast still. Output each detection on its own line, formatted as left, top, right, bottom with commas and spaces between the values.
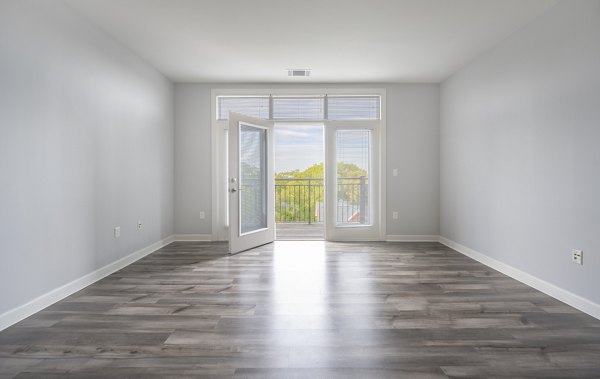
0, 241, 600, 379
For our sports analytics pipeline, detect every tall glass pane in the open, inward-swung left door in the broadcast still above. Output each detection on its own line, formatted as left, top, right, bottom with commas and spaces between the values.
239, 124, 267, 234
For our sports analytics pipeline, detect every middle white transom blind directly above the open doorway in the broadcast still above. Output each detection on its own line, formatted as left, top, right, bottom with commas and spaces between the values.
273, 97, 325, 120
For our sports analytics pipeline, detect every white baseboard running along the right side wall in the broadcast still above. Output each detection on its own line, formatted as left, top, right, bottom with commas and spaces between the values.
439, 236, 600, 319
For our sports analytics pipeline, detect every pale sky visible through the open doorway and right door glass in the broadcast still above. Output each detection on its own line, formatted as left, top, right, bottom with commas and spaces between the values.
274, 124, 369, 173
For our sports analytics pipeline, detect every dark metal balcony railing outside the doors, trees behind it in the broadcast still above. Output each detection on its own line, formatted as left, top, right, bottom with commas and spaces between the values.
275, 176, 369, 224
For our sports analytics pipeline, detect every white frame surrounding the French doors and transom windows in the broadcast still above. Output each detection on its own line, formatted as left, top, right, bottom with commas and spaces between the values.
210, 85, 387, 241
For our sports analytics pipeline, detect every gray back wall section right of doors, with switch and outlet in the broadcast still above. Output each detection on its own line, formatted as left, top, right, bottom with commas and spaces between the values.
386, 84, 440, 236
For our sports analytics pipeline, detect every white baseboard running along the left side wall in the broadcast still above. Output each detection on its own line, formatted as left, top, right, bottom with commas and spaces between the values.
0, 236, 174, 331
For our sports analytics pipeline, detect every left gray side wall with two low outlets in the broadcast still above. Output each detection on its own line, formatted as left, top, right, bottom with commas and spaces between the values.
0, 1, 173, 314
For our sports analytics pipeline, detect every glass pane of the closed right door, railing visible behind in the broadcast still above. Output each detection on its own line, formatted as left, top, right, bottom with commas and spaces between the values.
335, 130, 371, 226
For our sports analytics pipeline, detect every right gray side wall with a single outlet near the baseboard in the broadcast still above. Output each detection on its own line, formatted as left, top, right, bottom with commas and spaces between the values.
441, 0, 600, 303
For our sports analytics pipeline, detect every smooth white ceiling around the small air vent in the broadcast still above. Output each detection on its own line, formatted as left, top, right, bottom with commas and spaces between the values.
65, 0, 558, 83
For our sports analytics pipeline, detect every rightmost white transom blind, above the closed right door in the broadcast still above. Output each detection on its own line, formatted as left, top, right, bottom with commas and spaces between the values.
327, 96, 381, 120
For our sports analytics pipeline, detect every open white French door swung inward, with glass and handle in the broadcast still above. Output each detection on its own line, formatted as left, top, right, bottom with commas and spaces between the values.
228, 112, 275, 254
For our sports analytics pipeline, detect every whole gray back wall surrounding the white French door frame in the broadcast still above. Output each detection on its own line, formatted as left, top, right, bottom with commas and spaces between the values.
175, 83, 439, 235
